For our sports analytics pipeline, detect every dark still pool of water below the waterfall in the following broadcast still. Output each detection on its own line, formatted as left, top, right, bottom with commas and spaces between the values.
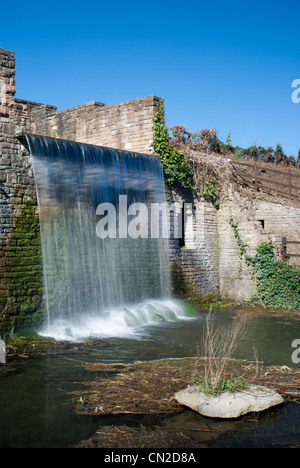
0, 311, 300, 448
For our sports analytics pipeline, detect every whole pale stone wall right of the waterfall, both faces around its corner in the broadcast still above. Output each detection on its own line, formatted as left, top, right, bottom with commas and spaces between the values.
166, 168, 300, 301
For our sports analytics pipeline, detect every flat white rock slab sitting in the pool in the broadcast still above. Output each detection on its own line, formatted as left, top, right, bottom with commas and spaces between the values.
175, 385, 284, 418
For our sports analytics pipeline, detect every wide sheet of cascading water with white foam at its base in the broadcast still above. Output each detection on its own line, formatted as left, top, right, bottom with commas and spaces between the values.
26, 135, 190, 340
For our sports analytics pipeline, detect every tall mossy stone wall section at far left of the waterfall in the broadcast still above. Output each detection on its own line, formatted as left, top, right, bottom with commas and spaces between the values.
0, 49, 42, 330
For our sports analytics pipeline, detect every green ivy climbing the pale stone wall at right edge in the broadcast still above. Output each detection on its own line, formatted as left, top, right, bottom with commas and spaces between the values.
229, 218, 300, 309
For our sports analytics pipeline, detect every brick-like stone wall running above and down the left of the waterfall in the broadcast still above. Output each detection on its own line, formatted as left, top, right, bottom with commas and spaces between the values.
0, 49, 161, 333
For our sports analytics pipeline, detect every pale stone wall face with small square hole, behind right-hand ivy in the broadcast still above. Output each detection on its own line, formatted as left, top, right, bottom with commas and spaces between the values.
217, 197, 300, 301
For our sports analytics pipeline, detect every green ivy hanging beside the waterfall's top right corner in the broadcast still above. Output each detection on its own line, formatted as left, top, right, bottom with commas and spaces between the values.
152, 104, 193, 189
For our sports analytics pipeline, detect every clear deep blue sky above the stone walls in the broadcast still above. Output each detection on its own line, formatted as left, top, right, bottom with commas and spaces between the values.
0, 0, 300, 155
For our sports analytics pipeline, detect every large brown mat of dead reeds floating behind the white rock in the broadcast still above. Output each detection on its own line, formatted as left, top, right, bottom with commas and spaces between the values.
65, 357, 300, 416
